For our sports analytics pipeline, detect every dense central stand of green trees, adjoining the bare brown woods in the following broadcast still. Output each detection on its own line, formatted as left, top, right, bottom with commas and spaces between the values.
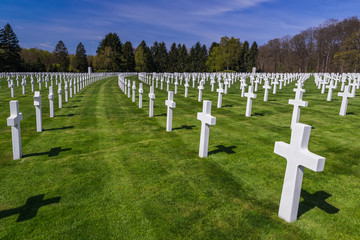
91, 33, 258, 72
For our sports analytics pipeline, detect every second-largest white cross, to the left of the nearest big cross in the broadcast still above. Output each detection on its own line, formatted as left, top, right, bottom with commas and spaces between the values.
197, 100, 216, 157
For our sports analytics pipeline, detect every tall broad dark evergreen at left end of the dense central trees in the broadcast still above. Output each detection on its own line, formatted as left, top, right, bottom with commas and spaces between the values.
96, 33, 122, 72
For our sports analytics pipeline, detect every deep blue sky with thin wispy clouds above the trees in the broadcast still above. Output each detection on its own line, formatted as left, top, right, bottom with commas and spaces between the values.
0, 0, 360, 54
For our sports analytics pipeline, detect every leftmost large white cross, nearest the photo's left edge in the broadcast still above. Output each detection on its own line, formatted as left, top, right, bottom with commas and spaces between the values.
7, 100, 23, 160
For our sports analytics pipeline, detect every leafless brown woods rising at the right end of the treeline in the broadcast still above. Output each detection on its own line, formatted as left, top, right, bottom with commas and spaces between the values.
257, 17, 360, 72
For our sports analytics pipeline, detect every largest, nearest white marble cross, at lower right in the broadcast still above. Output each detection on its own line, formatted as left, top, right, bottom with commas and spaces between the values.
274, 123, 325, 222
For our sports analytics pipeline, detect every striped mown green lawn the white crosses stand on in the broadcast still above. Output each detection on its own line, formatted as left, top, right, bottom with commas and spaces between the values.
0, 76, 360, 239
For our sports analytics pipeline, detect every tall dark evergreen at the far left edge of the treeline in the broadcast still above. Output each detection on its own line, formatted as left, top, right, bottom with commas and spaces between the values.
0, 23, 22, 71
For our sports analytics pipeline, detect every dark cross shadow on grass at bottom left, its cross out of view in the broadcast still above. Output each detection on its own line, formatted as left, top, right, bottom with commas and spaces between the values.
0, 194, 61, 222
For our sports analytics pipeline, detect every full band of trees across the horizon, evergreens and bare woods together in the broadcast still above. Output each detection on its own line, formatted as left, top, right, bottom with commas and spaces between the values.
0, 17, 360, 72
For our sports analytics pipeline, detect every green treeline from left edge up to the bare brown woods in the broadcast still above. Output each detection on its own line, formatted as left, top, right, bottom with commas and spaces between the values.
0, 24, 258, 72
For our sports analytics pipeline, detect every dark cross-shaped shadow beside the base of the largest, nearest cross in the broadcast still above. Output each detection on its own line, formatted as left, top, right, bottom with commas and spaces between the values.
298, 189, 340, 218
